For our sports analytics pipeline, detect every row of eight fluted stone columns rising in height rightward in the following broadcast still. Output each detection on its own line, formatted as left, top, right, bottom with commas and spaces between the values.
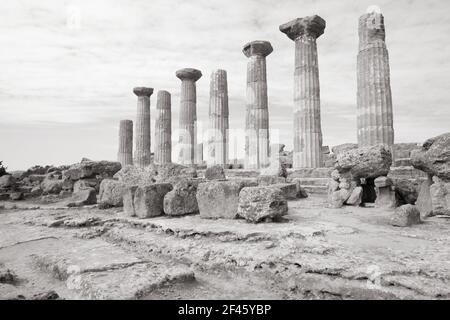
118, 6, 394, 169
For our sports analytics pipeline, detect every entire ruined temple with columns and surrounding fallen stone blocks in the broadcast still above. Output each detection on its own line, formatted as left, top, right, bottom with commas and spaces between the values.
0, 8, 450, 226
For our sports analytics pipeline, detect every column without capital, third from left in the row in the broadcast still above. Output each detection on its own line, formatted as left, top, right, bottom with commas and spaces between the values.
154, 90, 172, 164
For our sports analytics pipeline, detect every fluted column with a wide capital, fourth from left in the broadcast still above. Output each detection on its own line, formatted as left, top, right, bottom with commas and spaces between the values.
176, 68, 202, 165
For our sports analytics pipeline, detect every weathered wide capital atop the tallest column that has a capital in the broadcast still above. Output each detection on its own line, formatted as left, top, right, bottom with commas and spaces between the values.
280, 15, 326, 41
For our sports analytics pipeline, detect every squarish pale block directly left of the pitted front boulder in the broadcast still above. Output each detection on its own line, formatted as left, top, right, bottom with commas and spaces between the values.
196, 179, 257, 219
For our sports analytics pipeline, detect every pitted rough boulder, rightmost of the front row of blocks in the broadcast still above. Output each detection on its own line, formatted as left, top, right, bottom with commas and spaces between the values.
237, 186, 288, 223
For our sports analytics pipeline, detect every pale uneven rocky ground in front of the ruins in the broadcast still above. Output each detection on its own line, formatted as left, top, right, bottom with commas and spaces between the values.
0, 196, 450, 299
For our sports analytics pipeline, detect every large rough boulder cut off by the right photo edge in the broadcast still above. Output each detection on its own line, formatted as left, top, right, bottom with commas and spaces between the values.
411, 132, 450, 182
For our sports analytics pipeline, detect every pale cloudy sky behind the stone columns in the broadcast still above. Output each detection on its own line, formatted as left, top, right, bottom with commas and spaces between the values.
0, 0, 450, 170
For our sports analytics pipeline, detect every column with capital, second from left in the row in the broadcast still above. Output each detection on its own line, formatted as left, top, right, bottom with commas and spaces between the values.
133, 87, 153, 167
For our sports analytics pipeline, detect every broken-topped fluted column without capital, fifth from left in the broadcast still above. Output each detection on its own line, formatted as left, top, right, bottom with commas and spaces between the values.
207, 69, 229, 165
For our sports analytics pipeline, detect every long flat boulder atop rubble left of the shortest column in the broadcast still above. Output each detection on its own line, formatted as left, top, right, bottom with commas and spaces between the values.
63, 159, 122, 181
